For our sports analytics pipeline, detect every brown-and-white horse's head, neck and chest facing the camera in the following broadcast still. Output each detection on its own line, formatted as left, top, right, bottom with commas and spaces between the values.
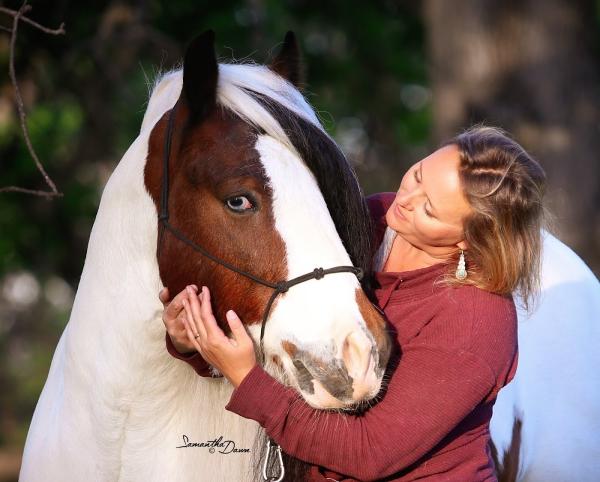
20, 31, 392, 482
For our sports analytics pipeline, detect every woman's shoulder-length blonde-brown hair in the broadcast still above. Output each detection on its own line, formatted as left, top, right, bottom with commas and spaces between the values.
444, 125, 546, 309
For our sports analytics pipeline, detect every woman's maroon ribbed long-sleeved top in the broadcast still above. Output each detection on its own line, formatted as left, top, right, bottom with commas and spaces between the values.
167, 193, 518, 482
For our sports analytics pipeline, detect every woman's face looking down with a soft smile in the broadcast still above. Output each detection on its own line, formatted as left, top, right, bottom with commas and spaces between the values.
386, 144, 471, 255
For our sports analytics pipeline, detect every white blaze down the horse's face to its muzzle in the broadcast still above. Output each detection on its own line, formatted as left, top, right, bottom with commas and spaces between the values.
255, 135, 366, 380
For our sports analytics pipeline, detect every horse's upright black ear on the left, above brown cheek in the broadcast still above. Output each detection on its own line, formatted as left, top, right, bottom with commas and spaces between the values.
181, 30, 219, 122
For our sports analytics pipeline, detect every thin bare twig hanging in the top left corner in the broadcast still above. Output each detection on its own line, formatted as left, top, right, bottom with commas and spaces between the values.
0, 0, 65, 197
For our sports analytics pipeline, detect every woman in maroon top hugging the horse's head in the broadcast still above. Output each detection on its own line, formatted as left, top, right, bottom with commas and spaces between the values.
160, 127, 545, 482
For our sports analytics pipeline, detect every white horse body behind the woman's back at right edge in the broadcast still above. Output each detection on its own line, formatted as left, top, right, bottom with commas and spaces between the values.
490, 232, 600, 482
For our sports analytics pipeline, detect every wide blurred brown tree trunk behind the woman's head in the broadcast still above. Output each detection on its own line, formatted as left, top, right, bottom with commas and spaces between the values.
424, 0, 600, 275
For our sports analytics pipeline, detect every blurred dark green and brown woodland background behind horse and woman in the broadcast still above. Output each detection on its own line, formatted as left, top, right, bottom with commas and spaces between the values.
0, 0, 600, 481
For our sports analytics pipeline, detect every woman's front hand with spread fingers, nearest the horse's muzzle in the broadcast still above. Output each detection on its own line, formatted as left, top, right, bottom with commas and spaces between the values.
181, 286, 256, 387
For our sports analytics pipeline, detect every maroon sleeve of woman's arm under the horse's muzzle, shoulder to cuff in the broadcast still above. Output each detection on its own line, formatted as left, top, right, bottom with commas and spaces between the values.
225, 287, 518, 480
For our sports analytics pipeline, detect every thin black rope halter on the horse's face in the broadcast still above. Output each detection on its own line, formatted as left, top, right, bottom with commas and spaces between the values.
158, 104, 363, 366
